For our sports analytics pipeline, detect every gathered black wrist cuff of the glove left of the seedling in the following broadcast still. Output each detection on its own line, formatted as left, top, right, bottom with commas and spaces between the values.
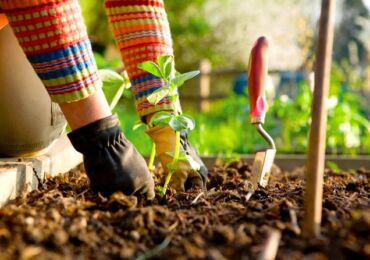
68, 114, 123, 154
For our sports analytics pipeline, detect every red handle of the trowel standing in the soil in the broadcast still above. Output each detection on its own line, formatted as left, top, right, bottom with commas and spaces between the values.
248, 37, 269, 124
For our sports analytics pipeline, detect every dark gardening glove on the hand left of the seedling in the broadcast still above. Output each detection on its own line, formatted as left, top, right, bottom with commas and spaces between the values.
68, 115, 155, 199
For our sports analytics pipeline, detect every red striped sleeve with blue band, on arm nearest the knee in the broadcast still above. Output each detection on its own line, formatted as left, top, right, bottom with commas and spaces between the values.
0, 0, 102, 103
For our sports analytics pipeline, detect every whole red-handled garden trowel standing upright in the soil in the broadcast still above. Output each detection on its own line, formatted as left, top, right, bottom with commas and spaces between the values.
248, 37, 276, 189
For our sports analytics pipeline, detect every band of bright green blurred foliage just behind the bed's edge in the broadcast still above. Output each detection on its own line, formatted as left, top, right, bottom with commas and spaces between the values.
106, 76, 370, 156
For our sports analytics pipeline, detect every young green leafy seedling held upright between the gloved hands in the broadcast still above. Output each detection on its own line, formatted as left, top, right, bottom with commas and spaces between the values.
138, 56, 200, 196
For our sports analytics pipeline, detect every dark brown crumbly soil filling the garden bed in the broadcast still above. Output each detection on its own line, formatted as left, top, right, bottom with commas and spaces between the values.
0, 163, 370, 260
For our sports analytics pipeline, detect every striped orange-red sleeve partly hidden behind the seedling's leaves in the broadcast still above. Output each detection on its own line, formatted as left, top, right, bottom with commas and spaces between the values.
105, 0, 173, 117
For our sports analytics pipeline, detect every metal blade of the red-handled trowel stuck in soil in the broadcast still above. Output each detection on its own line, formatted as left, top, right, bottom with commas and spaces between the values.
252, 149, 276, 189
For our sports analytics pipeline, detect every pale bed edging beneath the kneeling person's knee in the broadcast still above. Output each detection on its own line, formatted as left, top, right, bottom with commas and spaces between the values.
0, 135, 82, 207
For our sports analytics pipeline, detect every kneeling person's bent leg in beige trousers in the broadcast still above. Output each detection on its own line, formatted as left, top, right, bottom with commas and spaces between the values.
0, 26, 65, 156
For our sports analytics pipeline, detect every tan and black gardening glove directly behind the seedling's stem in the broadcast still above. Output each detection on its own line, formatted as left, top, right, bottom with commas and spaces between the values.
146, 126, 208, 191
